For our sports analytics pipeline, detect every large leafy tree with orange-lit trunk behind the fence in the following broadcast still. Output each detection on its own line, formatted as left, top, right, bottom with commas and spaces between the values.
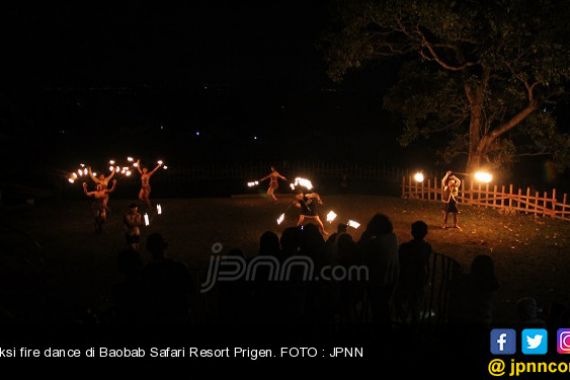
325, 0, 570, 171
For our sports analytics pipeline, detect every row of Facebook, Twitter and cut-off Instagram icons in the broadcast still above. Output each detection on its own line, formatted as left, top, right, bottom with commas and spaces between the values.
490, 329, 570, 355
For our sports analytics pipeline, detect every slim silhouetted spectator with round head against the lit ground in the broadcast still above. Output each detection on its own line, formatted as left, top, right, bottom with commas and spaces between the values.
395, 221, 431, 323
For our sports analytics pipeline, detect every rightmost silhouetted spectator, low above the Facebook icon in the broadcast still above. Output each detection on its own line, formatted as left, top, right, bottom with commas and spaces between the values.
449, 255, 499, 326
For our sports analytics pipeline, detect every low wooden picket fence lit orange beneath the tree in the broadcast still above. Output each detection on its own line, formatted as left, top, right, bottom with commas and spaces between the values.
402, 176, 570, 221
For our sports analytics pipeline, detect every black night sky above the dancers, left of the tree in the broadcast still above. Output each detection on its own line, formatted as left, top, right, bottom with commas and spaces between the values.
0, 1, 564, 189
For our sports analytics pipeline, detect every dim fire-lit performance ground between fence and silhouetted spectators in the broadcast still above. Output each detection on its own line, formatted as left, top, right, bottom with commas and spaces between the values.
0, 195, 570, 320
